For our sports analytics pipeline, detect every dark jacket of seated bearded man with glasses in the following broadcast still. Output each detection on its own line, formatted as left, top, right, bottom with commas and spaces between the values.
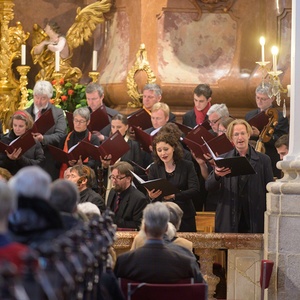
107, 185, 148, 229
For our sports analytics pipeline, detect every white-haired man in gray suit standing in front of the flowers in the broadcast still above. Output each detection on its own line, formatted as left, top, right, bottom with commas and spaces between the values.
26, 80, 67, 180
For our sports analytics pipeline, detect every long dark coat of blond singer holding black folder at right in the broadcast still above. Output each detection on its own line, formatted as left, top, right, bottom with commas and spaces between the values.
205, 147, 273, 233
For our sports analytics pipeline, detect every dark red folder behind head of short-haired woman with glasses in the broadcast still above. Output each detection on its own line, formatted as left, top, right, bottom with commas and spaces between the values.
66, 105, 110, 132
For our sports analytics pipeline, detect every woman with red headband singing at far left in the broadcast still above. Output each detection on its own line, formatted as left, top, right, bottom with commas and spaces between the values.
0, 110, 45, 175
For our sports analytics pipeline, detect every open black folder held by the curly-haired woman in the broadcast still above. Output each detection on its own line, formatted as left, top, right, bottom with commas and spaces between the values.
130, 171, 179, 197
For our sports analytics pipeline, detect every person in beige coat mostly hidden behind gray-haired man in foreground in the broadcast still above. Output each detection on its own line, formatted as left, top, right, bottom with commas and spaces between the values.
131, 202, 193, 253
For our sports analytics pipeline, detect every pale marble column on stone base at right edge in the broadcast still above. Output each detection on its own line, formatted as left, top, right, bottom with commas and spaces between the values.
264, 0, 300, 300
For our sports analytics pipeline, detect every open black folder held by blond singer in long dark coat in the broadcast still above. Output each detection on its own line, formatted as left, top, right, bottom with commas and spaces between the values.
203, 139, 256, 177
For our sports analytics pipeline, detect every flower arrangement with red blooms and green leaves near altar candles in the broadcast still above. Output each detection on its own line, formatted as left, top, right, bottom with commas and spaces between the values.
26, 78, 87, 112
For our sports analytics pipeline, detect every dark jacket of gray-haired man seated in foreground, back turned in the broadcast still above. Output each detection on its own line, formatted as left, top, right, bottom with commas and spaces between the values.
114, 241, 199, 283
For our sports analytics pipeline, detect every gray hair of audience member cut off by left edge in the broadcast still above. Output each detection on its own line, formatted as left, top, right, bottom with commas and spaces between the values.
0, 180, 17, 220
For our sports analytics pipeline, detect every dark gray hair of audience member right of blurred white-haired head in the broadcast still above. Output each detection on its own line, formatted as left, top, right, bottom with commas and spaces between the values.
49, 179, 80, 213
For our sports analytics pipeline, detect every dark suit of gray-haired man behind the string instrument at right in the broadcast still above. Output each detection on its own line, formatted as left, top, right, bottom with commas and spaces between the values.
245, 109, 289, 178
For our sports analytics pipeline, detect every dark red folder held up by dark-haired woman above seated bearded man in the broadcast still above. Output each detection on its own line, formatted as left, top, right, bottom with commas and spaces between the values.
84, 130, 130, 164
